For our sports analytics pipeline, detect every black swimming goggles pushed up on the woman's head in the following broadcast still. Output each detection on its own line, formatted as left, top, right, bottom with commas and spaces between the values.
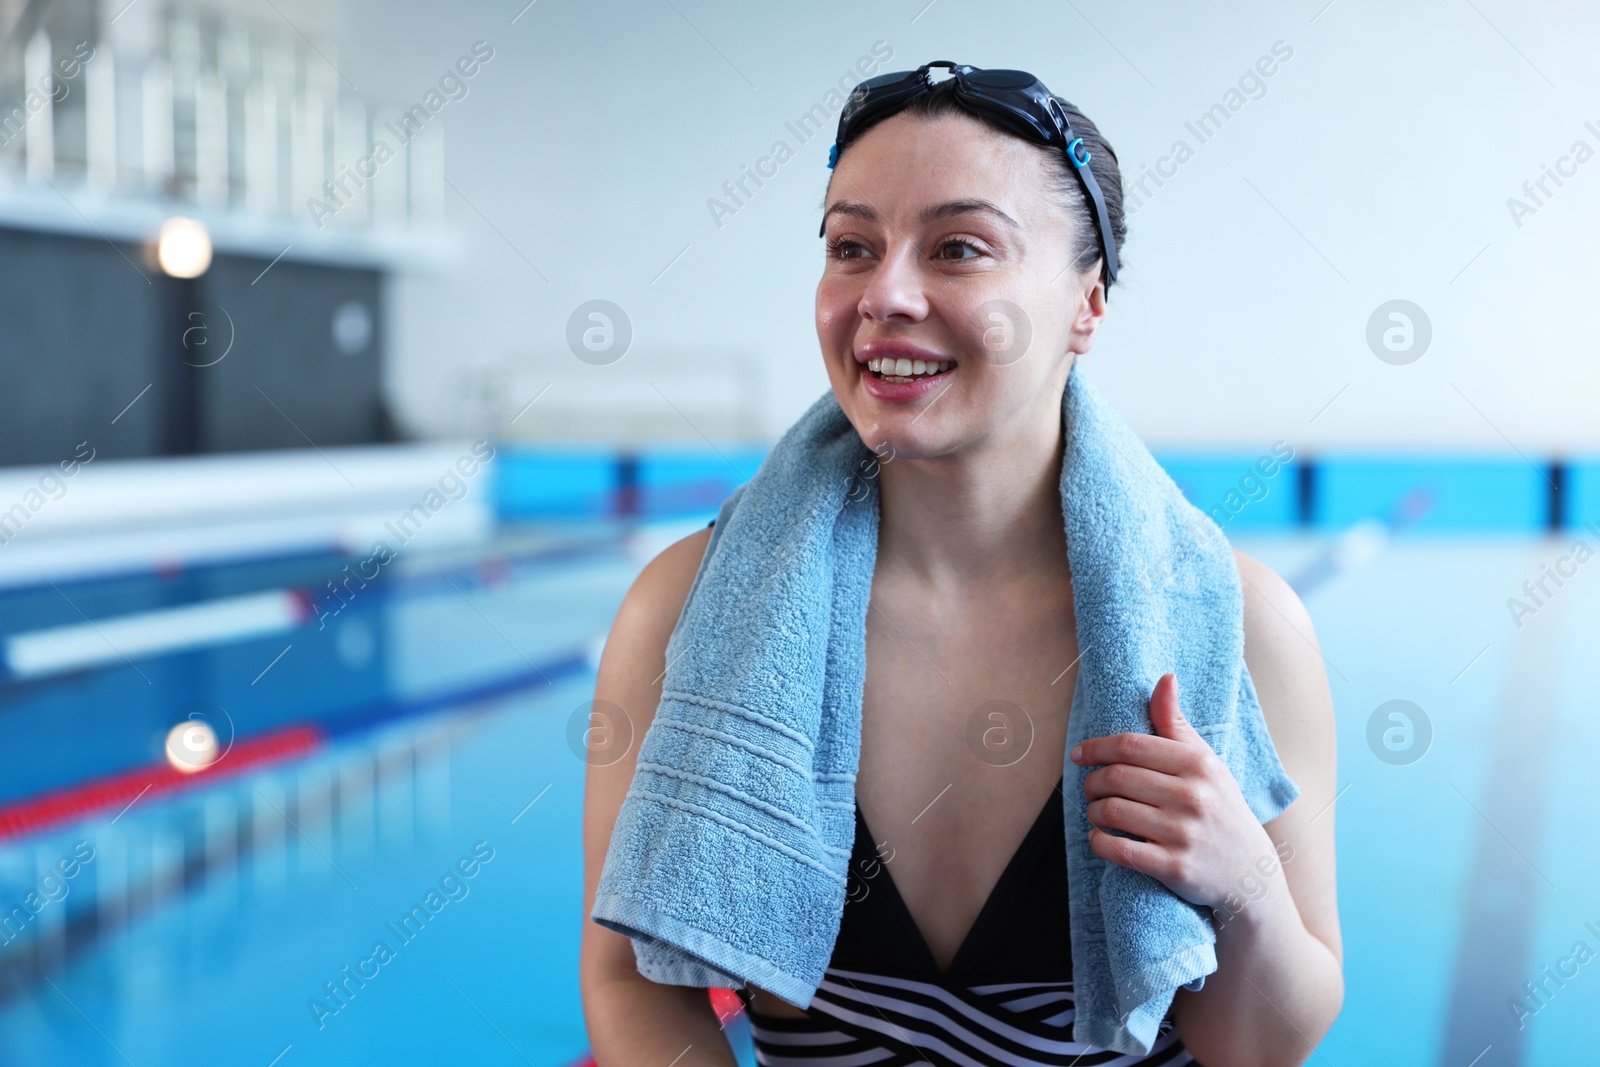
818, 59, 1117, 285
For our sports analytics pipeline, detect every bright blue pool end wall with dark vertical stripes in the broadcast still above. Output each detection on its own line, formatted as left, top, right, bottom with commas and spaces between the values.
494, 443, 1600, 534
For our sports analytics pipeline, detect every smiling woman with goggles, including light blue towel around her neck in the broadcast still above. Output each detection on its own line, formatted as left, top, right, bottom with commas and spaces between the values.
582, 64, 1342, 1067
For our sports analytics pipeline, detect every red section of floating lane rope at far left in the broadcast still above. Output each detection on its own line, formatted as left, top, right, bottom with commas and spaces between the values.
0, 725, 323, 841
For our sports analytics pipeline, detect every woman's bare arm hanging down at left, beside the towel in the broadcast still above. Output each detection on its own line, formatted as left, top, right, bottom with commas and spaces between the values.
579, 528, 736, 1067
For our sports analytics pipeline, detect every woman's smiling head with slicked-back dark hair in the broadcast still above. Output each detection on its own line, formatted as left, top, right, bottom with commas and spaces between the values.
816, 75, 1125, 453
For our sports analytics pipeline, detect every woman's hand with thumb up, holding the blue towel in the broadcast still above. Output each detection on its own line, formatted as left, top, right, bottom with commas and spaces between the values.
1072, 673, 1274, 907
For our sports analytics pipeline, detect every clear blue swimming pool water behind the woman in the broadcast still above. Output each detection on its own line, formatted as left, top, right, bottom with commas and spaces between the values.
0, 520, 1600, 1067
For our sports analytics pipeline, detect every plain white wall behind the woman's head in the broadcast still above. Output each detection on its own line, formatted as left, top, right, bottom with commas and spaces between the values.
338, 0, 1600, 456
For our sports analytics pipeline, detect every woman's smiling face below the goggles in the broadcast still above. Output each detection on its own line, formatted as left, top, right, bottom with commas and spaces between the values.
816, 112, 1106, 459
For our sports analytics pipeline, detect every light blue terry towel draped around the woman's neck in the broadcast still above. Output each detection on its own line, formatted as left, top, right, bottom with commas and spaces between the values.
592, 362, 1299, 1054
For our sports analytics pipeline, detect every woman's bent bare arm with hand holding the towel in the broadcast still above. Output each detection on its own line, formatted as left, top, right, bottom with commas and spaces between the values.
1069, 555, 1344, 1067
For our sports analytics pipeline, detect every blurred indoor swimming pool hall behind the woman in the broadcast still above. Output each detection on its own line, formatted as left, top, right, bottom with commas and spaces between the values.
0, 0, 1600, 1067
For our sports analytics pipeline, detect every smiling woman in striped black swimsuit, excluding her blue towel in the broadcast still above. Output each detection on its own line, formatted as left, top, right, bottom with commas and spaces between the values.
582, 64, 1344, 1067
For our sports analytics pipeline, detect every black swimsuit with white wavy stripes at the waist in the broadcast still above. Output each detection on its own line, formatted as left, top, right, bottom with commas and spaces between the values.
741, 784, 1195, 1067
